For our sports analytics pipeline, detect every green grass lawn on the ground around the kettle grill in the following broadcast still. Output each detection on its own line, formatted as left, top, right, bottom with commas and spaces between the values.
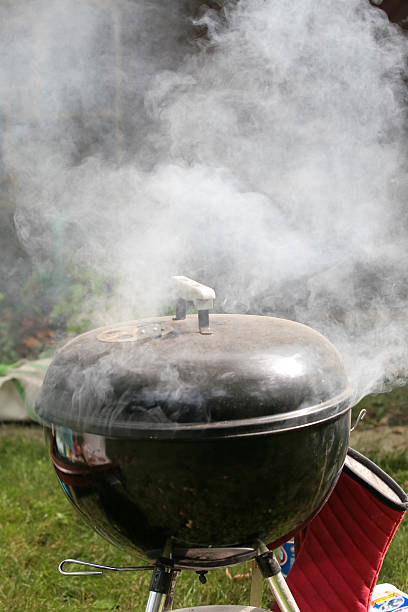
0, 390, 408, 612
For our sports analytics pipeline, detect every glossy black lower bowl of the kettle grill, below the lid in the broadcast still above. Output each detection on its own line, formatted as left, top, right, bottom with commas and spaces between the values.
48, 412, 350, 570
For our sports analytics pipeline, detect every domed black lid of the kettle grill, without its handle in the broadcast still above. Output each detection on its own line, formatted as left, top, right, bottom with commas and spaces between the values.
36, 315, 350, 437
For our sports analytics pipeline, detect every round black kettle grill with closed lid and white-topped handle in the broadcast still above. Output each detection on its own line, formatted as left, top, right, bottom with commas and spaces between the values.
36, 277, 351, 611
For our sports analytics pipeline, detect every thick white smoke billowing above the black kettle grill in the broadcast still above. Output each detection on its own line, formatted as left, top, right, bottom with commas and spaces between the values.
0, 0, 408, 398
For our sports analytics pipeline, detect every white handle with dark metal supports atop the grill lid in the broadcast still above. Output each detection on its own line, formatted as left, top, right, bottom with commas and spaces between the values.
172, 276, 215, 335
